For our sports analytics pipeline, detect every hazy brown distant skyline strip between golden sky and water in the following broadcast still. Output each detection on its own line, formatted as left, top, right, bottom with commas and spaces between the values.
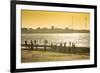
21, 26, 89, 33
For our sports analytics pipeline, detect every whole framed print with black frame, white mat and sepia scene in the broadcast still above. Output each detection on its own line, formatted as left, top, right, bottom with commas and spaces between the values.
11, 1, 97, 72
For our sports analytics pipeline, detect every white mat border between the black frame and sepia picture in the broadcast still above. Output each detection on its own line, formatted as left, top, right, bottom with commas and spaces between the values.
16, 5, 94, 68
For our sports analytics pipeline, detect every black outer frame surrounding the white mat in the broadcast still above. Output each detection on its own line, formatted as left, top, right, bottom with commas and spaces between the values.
10, 1, 97, 73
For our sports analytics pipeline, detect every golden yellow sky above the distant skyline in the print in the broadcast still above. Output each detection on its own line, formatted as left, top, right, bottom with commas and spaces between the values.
21, 10, 90, 29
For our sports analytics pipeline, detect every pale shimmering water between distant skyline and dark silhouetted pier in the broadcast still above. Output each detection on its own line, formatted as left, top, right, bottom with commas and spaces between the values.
21, 33, 90, 47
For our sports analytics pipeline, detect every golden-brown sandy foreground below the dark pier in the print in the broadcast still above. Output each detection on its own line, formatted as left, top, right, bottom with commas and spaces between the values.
21, 50, 90, 63
